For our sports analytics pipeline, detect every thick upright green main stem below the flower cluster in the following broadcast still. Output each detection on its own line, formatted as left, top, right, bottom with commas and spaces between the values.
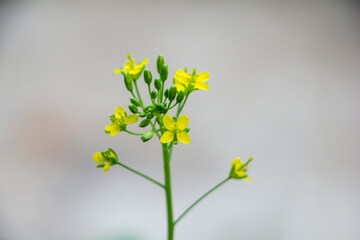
162, 143, 174, 240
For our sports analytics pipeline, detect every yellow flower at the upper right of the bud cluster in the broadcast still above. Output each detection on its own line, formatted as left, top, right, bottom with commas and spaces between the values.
174, 68, 210, 91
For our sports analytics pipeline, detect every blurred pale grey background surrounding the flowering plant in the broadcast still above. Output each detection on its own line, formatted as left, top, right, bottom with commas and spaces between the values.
0, 1, 360, 240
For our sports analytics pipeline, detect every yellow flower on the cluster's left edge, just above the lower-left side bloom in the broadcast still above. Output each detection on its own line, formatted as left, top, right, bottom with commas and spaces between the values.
105, 107, 139, 136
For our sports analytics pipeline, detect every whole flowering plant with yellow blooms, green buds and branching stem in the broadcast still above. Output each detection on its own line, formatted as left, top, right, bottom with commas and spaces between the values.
93, 54, 253, 240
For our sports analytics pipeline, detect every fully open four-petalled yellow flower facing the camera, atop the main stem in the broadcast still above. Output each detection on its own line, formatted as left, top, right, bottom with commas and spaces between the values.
160, 114, 191, 144
